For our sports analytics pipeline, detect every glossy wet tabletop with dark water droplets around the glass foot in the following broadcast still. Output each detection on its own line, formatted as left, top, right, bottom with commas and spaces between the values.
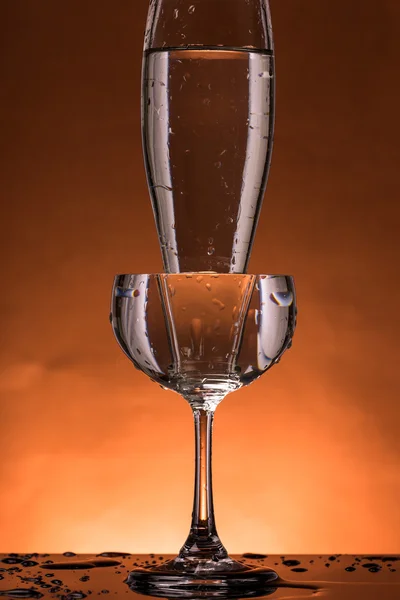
0, 552, 400, 600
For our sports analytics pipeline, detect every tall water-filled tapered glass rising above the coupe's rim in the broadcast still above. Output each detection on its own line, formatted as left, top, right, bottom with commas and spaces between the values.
142, 0, 275, 273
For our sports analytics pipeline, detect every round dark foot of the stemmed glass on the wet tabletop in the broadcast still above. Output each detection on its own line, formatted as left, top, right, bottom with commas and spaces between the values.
125, 557, 279, 599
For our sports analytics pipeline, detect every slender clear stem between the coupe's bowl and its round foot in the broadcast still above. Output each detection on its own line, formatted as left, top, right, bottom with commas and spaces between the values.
180, 408, 228, 560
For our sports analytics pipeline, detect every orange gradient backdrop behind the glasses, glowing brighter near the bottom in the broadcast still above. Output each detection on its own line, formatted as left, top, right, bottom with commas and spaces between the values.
0, 0, 400, 553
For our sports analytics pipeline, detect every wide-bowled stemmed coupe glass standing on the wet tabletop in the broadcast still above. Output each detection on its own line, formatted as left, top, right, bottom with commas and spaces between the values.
110, 273, 296, 598
